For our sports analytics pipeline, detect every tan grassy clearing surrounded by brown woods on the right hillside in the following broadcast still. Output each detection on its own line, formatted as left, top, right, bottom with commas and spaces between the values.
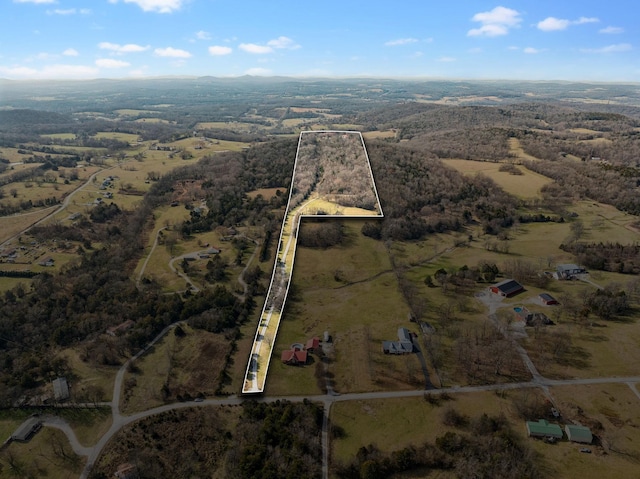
442, 159, 552, 198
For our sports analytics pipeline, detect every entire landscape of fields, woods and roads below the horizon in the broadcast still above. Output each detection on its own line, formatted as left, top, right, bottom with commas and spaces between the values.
0, 76, 640, 479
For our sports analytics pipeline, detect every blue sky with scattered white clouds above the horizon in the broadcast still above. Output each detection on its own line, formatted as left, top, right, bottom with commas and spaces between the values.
0, 0, 640, 81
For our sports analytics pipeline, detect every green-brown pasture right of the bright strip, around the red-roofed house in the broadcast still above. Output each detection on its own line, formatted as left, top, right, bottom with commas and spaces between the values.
266, 220, 420, 394
